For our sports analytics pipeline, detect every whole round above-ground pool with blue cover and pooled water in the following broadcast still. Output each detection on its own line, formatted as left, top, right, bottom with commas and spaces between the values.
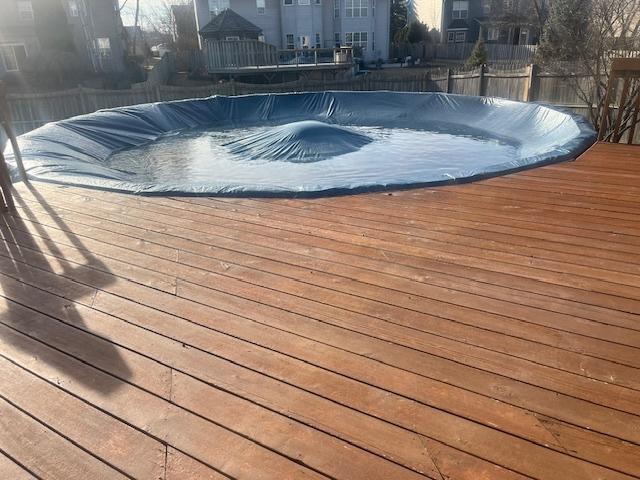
7, 92, 595, 195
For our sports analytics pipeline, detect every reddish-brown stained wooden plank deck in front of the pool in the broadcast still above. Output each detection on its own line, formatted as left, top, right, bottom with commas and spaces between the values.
0, 144, 640, 480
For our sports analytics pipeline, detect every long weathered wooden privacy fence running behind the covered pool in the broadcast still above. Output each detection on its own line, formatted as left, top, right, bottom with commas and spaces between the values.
0, 65, 608, 137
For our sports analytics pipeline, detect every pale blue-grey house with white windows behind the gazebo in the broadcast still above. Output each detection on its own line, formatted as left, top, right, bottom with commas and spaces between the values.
194, 0, 391, 61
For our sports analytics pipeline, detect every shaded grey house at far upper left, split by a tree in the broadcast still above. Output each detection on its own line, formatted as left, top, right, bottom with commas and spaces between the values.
0, 0, 124, 75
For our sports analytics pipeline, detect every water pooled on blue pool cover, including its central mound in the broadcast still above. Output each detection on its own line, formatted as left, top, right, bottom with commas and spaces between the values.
105, 122, 518, 186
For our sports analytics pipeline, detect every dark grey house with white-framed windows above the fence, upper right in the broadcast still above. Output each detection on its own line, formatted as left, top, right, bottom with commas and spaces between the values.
441, 0, 545, 45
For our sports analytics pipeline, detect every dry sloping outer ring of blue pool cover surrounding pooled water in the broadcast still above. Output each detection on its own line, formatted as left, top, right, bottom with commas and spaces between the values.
5, 91, 596, 197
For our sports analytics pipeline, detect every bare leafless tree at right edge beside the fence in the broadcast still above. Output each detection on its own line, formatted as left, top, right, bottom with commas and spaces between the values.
538, 0, 640, 135
